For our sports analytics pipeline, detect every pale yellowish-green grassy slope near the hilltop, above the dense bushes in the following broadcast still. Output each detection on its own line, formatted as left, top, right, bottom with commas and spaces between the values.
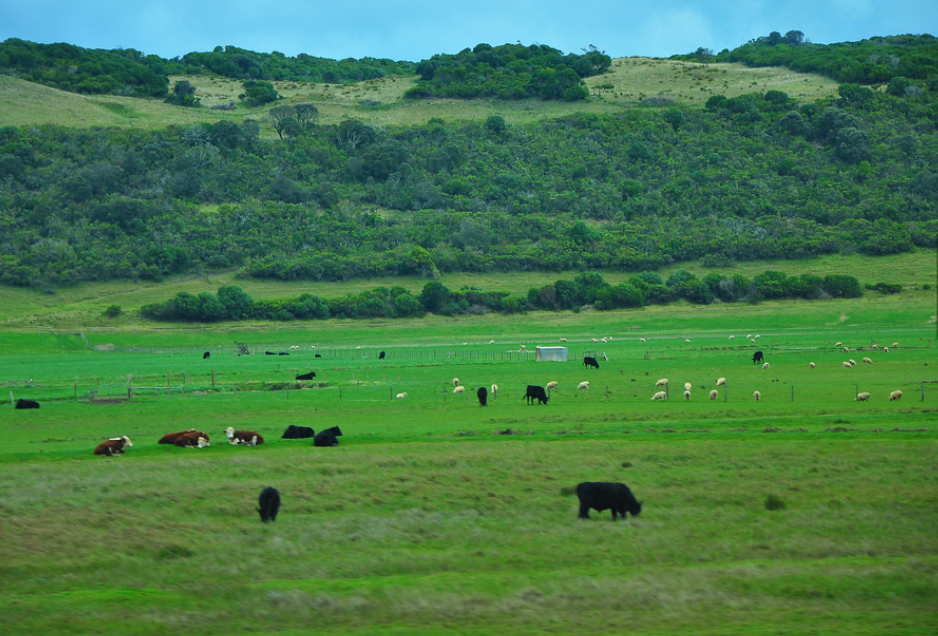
0, 58, 837, 130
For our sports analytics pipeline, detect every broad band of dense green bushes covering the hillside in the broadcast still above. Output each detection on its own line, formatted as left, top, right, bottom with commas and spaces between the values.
0, 34, 938, 286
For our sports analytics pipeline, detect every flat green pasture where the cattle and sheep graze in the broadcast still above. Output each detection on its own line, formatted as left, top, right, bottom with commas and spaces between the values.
0, 265, 938, 636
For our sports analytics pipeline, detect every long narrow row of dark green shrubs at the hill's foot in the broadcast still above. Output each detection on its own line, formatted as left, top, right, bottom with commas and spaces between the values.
135, 269, 868, 322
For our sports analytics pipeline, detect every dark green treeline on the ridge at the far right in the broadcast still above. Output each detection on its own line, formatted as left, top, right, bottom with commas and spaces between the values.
674, 32, 938, 90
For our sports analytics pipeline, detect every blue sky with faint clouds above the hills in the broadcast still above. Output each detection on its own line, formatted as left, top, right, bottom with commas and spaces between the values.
0, 0, 938, 62
